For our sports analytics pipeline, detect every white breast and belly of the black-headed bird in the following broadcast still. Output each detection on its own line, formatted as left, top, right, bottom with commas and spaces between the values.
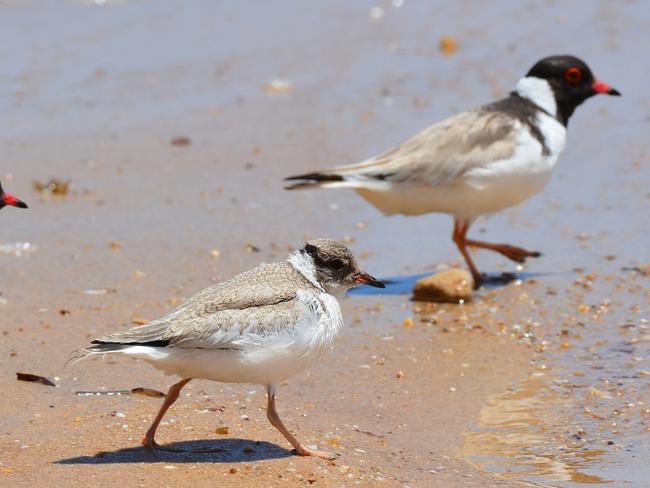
355, 115, 566, 219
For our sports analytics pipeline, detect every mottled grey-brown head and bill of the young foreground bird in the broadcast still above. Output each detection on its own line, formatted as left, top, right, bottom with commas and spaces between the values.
300, 239, 384, 293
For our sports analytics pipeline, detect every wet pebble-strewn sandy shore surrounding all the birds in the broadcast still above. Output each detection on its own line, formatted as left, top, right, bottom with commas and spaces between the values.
0, 1, 650, 487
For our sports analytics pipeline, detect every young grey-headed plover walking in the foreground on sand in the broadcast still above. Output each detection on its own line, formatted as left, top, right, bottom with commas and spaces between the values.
71, 239, 384, 458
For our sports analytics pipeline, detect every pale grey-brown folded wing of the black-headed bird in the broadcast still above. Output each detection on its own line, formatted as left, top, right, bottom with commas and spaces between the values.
331, 109, 518, 186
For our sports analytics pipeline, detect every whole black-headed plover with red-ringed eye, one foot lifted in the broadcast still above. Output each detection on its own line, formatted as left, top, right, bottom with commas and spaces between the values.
286, 55, 620, 285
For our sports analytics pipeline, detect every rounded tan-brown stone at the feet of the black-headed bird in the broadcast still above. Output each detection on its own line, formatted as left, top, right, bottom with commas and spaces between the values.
413, 268, 474, 303
